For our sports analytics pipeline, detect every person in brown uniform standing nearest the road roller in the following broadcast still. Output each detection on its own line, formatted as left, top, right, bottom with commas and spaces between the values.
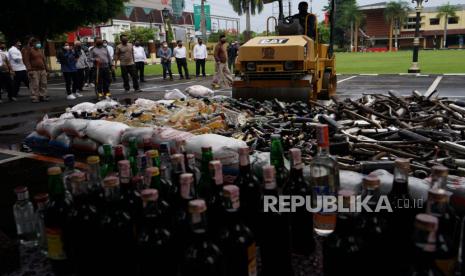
212, 35, 232, 88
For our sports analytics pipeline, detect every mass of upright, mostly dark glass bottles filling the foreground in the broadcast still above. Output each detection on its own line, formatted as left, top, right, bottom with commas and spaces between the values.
14, 125, 461, 276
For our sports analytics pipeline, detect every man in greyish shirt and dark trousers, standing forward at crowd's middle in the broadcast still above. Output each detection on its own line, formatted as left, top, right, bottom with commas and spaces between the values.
90, 37, 112, 99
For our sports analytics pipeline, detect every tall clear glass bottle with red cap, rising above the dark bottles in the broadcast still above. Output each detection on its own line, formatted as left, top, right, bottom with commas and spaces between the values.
310, 124, 339, 236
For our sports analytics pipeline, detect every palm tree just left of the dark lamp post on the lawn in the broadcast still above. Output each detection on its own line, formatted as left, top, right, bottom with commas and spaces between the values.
384, 1, 410, 51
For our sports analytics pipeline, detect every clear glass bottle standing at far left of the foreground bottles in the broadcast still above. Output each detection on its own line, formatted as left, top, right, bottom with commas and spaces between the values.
13, 186, 39, 247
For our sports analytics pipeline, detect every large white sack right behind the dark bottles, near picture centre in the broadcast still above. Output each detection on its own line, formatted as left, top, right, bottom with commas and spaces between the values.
186, 134, 247, 185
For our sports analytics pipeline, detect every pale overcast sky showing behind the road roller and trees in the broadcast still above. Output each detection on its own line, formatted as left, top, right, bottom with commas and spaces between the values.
185, 0, 465, 32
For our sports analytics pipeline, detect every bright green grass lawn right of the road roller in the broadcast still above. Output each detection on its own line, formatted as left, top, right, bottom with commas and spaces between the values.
336, 50, 465, 74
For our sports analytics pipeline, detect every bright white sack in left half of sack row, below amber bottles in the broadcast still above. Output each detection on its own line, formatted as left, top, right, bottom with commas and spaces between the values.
86, 120, 129, 146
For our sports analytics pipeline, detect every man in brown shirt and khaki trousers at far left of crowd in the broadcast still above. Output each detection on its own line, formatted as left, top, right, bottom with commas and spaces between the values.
21, 37, 49, 103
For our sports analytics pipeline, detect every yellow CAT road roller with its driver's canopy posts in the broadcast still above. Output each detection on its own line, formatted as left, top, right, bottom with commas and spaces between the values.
232, 0, 337, 102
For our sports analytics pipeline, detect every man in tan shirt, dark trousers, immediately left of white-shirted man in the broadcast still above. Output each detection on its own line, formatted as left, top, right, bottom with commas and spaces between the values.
115, 35, 142, 93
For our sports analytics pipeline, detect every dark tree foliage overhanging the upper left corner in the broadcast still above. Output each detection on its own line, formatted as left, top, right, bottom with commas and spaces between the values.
0, 0, 127, 40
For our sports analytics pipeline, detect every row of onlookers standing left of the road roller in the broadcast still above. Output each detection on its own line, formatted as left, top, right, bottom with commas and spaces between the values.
0, 34, 239, 103
